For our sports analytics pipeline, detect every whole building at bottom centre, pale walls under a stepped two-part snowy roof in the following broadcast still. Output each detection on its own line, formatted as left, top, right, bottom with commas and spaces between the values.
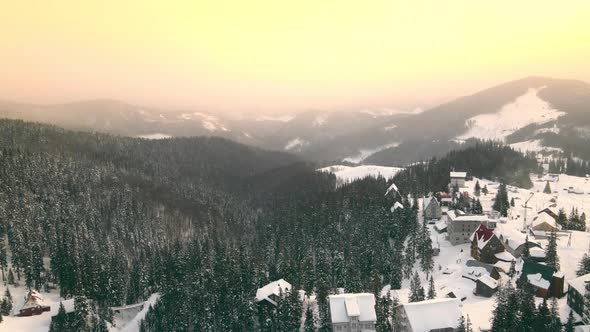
328, 293, 377, 332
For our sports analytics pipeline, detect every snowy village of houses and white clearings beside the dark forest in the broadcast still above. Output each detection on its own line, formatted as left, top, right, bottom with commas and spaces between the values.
1, 171, 590, 332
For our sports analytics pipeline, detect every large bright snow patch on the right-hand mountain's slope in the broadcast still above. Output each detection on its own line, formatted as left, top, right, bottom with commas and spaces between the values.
457, 88, 565, 141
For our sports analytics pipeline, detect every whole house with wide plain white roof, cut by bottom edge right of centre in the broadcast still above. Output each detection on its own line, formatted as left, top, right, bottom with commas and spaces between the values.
393, 298, 463, 332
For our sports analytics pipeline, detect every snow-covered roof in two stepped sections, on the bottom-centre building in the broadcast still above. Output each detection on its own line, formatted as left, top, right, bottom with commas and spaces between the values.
328, 293, 377, 323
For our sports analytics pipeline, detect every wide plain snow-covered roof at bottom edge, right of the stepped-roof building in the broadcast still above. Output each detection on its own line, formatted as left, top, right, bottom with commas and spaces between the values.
403, 298, 463, 332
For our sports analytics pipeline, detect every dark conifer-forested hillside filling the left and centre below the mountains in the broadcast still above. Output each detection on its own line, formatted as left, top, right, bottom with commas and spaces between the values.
0, 120, 432, 331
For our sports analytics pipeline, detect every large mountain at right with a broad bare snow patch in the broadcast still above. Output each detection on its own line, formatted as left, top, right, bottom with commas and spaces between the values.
365, 77, 590, 164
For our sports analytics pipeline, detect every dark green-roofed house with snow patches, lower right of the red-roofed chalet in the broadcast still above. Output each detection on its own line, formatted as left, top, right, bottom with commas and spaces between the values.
521, 258, 565, 298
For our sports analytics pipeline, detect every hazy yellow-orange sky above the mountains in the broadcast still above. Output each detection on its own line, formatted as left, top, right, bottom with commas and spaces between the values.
0, 0, 590, 112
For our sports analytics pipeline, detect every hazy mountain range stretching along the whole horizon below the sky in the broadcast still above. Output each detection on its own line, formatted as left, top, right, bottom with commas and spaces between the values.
0, 77, 590, 165
